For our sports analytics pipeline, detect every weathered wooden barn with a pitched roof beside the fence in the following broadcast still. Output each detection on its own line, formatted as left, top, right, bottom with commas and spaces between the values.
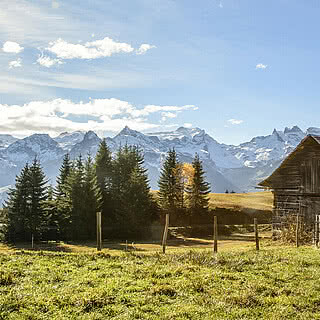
259, 135, 320, 233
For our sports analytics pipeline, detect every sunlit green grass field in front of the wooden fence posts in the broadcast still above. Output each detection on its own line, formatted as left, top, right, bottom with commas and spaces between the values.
0, 240, 320, 319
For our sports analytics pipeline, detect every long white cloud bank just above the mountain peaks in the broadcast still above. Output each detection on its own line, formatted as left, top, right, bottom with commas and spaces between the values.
0, 98, 195, 136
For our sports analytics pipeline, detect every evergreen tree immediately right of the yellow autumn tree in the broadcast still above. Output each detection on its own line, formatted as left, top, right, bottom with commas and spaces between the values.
186, 154, 210, 216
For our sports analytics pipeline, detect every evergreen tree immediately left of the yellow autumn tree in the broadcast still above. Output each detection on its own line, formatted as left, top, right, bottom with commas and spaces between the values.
158, 149, 183, 213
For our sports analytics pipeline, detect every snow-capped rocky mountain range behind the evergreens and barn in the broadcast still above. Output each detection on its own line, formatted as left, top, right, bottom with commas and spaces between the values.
0, 126, 320, 205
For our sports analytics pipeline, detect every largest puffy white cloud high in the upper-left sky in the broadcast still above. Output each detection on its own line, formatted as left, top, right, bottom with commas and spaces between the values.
46, 37, 134, 59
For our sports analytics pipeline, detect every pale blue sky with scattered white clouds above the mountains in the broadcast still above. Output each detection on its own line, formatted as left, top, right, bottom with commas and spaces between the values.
0, 0, 320, 144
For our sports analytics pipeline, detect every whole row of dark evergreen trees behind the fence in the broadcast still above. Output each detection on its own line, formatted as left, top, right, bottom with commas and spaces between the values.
4, 140, 210, 242
